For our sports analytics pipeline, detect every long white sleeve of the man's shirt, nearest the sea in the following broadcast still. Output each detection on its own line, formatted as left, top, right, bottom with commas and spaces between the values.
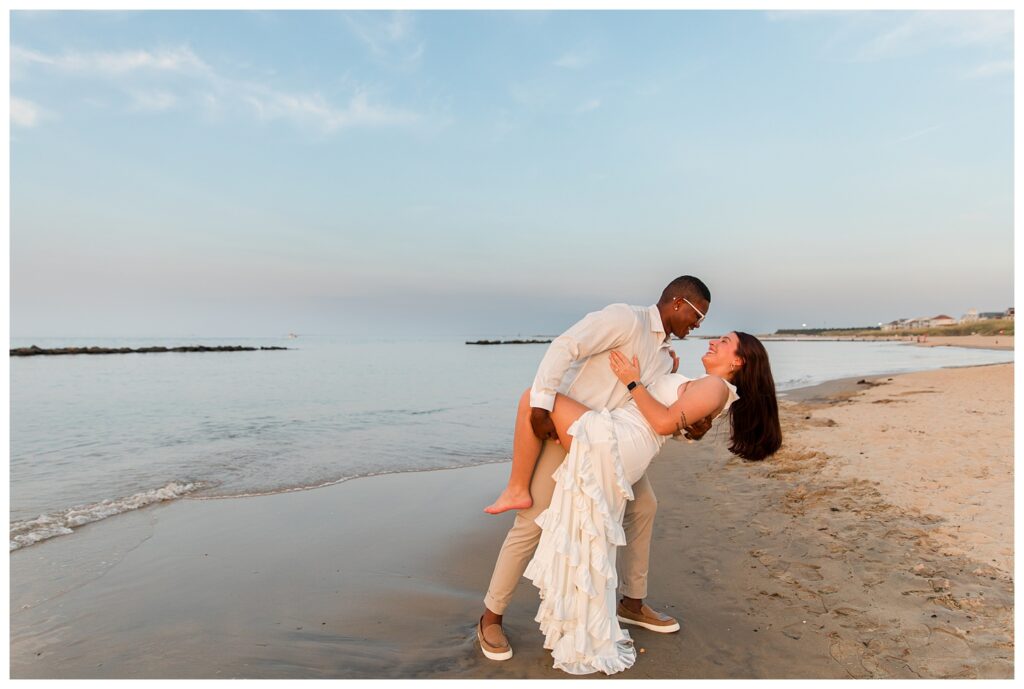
529, 304, 637, 412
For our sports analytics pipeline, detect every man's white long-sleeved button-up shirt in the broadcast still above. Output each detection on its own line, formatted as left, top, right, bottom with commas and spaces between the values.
529, 304, 672, 412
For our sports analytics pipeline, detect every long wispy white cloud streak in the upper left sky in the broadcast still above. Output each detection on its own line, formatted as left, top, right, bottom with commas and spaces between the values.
11, 44, 420, 132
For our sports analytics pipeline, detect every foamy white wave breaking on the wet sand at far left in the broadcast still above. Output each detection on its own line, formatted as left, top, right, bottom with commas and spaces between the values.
10, 481, 205, 551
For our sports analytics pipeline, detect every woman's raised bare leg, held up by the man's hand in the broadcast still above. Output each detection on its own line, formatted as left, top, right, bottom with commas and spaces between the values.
483, 389, 590, 514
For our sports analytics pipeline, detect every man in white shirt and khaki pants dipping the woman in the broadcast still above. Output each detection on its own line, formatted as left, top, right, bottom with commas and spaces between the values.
477, 275, 711, 660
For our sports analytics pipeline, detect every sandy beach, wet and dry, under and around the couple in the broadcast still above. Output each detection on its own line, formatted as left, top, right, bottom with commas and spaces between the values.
10, 364, 1014, 679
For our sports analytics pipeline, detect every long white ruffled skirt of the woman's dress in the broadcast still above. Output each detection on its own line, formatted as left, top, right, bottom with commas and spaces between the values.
524, 411, 636, 675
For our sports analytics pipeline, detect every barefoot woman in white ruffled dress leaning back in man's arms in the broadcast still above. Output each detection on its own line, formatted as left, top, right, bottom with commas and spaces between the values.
488, 333, 781, 675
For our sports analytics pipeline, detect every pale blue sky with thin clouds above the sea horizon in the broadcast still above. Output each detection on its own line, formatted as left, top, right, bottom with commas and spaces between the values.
10, 11, 1013, 337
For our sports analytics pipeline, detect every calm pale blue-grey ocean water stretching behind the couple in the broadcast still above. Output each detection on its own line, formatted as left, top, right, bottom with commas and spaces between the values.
10, 337, 1013, 550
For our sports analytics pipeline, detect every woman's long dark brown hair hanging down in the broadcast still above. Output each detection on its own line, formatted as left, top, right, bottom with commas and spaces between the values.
729, 332, 782, 461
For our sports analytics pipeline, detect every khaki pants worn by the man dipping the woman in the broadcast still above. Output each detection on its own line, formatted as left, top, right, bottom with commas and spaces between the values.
483, 441, 657, 615
